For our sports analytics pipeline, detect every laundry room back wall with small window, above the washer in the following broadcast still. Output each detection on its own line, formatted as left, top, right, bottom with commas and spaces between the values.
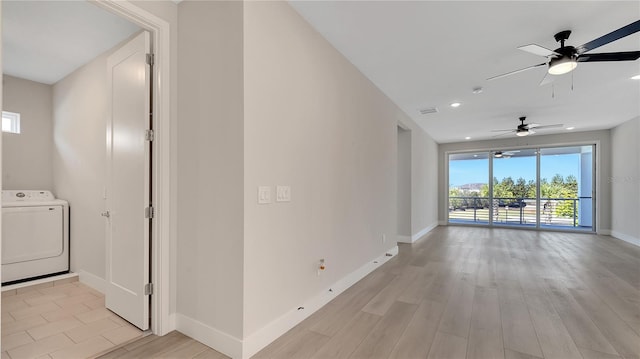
2, 75, 53, 190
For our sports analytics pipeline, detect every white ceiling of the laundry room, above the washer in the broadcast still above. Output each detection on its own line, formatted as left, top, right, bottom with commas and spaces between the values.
2, 0, 140, 84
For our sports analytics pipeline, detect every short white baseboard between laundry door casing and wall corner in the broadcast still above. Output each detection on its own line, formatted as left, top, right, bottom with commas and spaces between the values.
176, 313, 243, 358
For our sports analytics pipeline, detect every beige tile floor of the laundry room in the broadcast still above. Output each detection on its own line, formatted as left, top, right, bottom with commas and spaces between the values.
2, 277, 143, 359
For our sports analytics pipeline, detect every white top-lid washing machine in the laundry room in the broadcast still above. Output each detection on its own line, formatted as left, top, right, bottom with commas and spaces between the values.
2, 190, 69, 284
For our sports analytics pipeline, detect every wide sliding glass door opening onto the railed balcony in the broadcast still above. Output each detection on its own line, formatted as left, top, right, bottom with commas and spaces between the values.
448, 145, 595, 231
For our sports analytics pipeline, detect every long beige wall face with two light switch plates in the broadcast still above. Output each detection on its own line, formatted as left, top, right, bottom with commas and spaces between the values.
244, 2, 406, 337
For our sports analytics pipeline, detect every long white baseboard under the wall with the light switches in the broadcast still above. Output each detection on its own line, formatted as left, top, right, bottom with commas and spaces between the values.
242, 246, 398, 358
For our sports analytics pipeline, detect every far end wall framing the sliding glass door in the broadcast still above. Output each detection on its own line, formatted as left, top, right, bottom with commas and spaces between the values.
438, 130, 612, 234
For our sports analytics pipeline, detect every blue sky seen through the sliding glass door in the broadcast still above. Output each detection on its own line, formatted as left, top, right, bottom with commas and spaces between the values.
449, 154, 580, 187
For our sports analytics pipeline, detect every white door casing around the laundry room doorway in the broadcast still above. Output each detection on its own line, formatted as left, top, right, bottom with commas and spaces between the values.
90, 0, 176, 335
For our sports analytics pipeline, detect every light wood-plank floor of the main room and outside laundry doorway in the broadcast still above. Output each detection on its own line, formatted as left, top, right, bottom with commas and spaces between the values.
97, 226, 640, 359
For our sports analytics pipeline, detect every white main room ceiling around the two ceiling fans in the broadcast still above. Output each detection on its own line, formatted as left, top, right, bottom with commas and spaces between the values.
290, 1, 640, 143
